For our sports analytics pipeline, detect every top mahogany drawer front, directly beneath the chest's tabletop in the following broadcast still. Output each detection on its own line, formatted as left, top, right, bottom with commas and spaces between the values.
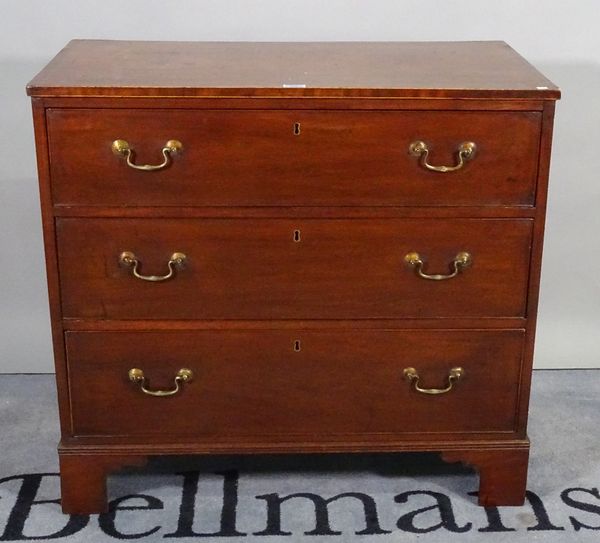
48, 109, 541, 206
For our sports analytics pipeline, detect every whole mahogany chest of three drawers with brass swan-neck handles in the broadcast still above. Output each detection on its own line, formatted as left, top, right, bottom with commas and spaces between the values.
28, 41, 559, 513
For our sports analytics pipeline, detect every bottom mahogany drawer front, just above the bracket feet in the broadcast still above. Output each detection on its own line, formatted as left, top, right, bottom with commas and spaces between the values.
66, 330, 523, 441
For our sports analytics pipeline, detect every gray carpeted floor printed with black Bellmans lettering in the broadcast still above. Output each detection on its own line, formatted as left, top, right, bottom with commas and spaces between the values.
0, 370, 600, 543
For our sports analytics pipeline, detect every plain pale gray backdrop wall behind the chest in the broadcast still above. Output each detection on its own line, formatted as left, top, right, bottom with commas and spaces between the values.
0, 0, 600, 373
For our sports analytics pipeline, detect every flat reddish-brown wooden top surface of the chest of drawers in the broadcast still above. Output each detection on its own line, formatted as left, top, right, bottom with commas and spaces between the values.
27, 40, 560, 99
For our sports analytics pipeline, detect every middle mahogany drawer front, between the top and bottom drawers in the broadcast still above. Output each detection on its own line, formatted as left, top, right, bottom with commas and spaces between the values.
57, 218, 533, 320
